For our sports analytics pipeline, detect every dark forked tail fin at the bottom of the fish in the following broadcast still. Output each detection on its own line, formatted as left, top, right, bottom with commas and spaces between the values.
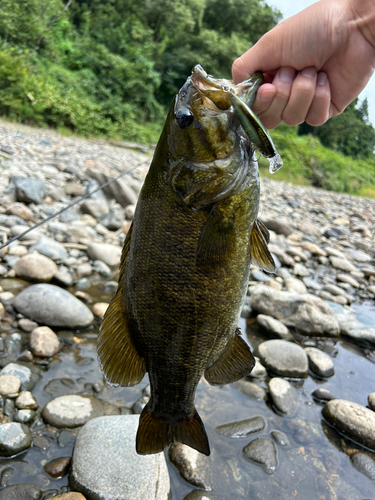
136, 403, 210, 456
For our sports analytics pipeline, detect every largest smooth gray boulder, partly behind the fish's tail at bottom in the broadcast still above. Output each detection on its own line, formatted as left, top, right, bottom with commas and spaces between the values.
70, 415, 170, 500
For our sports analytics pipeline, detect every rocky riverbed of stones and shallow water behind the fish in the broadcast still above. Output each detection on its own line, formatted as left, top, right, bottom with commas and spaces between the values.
0, 122, 375, 500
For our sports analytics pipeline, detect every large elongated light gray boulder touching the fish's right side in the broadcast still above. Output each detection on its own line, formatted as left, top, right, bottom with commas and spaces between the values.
250, 285, 339, 337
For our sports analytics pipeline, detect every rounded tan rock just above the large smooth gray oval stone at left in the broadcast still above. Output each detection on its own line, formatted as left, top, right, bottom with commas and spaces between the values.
13, 252, 57, 282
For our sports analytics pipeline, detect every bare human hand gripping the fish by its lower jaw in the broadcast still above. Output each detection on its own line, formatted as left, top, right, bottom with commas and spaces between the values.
232, 0, 375, 129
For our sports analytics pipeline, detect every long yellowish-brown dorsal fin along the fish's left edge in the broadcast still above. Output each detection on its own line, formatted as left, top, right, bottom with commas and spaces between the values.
97, 228, 146, 386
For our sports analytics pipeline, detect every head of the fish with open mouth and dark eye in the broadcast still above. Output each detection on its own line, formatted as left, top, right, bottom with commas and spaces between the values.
168, 65, 263, 207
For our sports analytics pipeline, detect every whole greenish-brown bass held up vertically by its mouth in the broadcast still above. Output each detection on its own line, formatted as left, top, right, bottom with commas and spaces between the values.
97, 65, 275, 455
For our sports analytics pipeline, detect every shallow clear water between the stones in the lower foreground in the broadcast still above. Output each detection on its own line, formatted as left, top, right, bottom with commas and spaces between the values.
0, 280, 375, 500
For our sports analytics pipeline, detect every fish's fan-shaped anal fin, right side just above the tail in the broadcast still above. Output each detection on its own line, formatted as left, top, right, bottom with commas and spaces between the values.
204, 330, 255, 385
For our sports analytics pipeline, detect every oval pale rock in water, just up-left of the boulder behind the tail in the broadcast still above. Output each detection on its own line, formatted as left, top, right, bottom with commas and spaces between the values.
42, 394, 104, 429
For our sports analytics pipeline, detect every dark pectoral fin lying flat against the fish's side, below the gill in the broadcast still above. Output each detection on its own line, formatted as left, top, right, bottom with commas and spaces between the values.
196, 206, 236, 267
